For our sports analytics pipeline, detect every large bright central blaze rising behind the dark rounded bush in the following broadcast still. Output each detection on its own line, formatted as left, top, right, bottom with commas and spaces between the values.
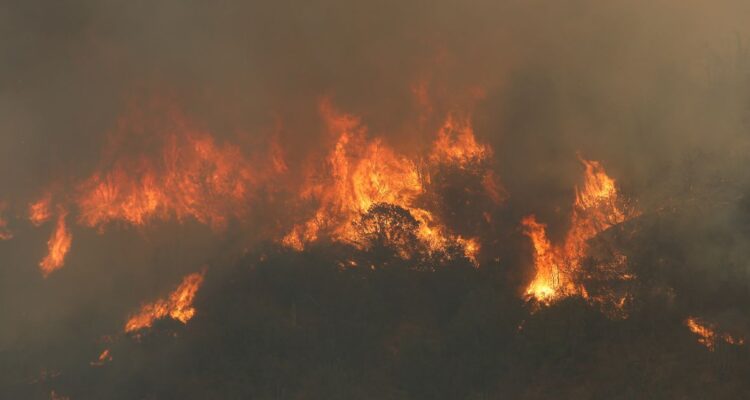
282, 100, 488, 260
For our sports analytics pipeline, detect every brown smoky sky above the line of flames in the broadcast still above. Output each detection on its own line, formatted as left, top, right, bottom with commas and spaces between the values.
0, 1, 748, 209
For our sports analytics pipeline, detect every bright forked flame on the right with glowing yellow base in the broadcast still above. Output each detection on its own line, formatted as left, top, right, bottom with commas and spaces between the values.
521, 159, 637, 304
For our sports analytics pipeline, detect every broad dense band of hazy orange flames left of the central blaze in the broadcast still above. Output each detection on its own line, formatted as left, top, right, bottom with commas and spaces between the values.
78, 134, 254, 229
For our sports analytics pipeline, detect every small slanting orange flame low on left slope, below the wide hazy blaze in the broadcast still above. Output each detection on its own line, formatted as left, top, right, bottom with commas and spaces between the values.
125, 270, 205, 332
